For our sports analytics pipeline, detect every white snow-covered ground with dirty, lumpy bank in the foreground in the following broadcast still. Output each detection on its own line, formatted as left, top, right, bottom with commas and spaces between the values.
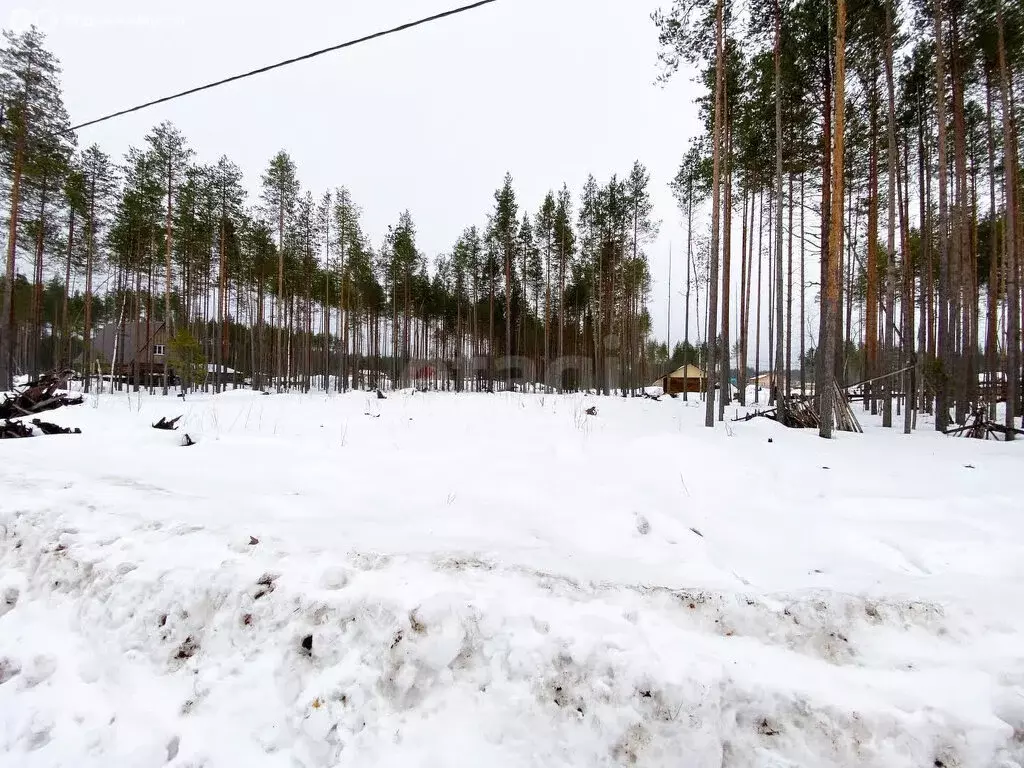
0, 391, 1024, 768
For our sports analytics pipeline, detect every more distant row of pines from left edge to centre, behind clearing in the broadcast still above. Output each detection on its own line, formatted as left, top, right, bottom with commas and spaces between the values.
0, 29, 658, 393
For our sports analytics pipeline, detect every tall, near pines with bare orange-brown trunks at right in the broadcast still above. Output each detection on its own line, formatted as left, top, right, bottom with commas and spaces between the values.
653, 0, 1024, 434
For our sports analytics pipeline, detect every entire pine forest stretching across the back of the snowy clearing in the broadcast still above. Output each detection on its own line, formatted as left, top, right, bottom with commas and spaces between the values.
0, 0, 1024, 436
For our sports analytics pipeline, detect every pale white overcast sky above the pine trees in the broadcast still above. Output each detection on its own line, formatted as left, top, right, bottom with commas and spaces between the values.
12, 0, 712, 348
